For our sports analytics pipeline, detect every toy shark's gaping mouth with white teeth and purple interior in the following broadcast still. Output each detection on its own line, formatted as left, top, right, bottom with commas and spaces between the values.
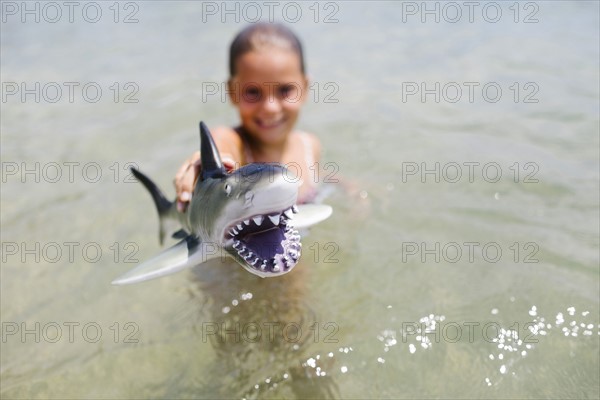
225, 205, 302, 273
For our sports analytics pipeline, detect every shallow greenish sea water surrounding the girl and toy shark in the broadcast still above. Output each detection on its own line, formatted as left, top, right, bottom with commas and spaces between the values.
0, 1, 600, 399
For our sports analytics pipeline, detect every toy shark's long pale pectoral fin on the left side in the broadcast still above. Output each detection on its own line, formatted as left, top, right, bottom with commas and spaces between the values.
112, 236, 205, 285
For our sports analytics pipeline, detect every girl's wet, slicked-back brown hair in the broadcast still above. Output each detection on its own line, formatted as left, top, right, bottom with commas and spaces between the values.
229, 22, 305, 77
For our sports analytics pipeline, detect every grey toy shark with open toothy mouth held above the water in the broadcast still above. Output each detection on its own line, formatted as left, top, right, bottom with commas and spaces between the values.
112, 122, 304, 285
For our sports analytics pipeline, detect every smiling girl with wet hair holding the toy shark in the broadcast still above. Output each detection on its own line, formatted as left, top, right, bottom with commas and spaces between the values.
175, 23, 321, 211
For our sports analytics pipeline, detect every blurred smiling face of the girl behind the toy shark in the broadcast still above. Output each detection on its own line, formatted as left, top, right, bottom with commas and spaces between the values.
229, 48, 308, 144
